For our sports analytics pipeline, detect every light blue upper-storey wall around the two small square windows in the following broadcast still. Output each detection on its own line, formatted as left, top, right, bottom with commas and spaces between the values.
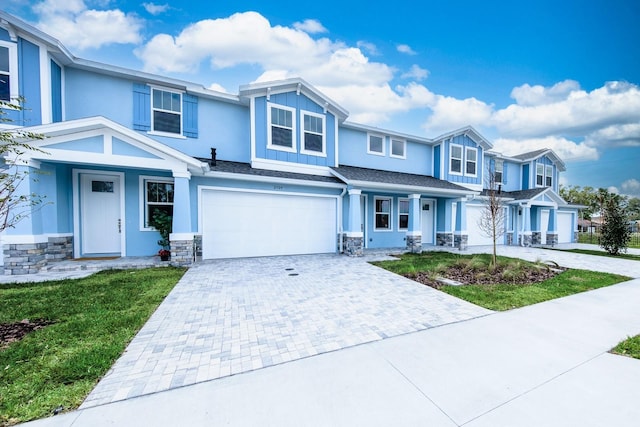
338, 127, 433, 176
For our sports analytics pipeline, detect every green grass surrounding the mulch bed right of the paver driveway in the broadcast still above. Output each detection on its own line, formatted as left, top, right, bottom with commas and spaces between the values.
375, 252, 630, 311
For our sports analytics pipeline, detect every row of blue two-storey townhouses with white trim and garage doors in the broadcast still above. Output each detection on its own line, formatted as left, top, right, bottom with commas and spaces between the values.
0, 12, 577, 274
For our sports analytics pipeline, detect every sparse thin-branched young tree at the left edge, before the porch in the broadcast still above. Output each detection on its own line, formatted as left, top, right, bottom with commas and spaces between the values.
0, 101, 44, 232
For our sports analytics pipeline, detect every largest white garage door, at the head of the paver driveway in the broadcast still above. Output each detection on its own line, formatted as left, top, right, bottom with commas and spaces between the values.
201, 190, 337, 259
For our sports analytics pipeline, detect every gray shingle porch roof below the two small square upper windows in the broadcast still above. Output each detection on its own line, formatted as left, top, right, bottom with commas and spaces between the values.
331, 166, 473, 194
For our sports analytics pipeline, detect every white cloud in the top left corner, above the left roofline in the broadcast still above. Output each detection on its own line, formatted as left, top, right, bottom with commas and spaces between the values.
33, 0, 142, 49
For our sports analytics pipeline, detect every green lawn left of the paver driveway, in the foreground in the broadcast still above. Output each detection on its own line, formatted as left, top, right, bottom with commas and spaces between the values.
0, 267, 185, 426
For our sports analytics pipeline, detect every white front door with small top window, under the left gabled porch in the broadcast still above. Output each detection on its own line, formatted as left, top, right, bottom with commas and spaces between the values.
80, 174, 122, 255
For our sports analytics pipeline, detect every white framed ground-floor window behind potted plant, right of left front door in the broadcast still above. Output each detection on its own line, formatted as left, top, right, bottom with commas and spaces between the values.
140, 176, 174, 231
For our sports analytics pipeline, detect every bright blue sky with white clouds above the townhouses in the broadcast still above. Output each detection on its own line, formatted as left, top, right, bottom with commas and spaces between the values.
3, 0, 640, 196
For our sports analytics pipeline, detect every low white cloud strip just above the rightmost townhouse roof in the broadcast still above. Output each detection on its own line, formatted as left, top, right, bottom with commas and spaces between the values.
493, 136, 599, 162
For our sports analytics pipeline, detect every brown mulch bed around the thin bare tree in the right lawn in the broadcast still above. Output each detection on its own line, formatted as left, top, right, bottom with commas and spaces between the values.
406, 265, 564, 289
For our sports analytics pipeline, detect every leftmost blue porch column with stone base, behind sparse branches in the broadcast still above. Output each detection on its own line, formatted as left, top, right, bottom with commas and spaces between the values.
2, 162, 48, 275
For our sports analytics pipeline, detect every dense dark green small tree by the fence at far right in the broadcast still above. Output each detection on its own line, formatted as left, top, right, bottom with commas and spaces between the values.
598, 191, 631, 255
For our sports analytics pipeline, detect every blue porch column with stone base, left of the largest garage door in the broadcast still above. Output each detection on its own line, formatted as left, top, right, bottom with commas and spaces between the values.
169, 171, 196, 265
